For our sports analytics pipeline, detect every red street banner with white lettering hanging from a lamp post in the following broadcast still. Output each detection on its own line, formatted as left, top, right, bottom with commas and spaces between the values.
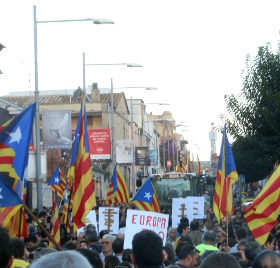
88, 128, 111, 160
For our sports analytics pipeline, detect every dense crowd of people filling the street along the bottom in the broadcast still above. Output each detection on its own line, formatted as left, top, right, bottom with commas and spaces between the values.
0, 196, 280, 268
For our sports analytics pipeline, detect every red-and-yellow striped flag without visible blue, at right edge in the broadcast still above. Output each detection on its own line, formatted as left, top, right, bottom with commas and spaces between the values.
244, 165, 280, 245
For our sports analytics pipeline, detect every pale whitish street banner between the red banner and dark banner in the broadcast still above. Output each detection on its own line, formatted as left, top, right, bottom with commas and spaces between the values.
116, 139, 133, 164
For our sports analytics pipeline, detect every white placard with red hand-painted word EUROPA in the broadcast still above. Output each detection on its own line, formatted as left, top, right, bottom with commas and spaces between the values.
124, 209, 169, 248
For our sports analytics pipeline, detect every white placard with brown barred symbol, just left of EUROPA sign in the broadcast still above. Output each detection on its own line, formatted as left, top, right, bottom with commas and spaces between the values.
99, 207, 119, 234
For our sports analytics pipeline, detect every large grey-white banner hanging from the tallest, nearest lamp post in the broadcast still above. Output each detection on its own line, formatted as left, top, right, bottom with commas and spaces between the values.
42, 110, 72, 150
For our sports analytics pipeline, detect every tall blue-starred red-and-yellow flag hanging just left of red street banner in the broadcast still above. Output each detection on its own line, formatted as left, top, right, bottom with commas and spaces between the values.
69, 96, 96, 233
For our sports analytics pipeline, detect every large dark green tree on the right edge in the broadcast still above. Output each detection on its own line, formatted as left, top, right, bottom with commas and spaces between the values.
221, 44, 280, 181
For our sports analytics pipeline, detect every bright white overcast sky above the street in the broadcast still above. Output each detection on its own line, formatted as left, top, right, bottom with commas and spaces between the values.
0, 0, 280, 160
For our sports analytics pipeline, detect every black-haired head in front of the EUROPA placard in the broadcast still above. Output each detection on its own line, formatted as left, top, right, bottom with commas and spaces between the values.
132, 230, 163, 268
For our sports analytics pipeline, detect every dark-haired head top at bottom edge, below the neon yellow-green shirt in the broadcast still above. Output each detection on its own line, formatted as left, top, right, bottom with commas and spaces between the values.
199, 251, 240, 268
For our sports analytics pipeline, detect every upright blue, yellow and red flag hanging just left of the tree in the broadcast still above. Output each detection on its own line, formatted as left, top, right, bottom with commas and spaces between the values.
213, 126, 238, 223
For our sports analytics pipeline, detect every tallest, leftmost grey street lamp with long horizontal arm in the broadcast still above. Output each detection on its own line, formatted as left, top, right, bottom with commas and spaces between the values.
33, 5, 114, 212
